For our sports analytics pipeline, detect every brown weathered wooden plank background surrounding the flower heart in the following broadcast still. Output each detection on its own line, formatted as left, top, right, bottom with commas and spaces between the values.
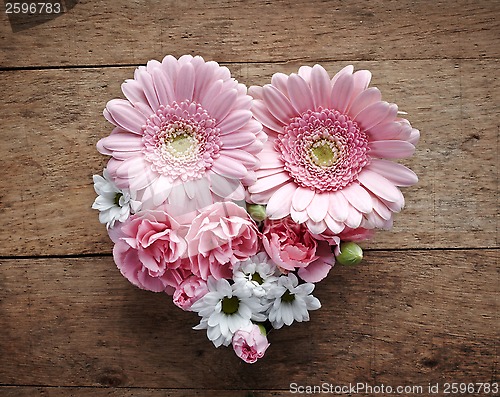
0, 0, 500, 397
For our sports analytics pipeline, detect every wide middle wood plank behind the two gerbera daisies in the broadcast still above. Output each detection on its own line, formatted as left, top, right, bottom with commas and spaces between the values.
0, 60, 500, 256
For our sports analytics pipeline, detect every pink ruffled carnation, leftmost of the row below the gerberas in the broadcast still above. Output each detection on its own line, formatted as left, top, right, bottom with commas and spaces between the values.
110, 211, 189, 292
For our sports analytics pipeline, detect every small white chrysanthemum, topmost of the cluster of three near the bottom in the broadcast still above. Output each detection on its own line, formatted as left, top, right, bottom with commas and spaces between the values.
233, 252, 278, 298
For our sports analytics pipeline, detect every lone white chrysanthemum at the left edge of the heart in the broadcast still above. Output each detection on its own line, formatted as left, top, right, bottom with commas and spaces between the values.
92, 169, 140, 229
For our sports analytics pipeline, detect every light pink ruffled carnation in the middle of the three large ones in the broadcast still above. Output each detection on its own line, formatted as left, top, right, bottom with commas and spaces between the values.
186, 202, 260, 280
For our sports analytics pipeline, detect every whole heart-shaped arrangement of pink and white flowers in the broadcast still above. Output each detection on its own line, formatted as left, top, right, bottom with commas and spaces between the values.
93, 55, 419, 363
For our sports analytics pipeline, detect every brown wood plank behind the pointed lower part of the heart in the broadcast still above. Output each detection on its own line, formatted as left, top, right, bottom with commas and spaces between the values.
0, 250, 500, 386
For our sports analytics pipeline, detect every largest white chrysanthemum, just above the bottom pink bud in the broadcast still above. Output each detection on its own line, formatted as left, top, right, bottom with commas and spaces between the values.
191, 277, 266, 347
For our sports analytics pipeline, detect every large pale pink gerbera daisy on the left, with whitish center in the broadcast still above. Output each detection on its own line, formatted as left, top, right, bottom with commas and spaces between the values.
97, 55, 266, 209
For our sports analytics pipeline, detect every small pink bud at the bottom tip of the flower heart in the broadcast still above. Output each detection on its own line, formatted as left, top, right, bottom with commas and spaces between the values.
233, 324, 269, 364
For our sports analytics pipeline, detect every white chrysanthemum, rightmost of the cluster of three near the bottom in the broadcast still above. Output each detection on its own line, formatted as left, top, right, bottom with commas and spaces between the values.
268, 273, 321, 329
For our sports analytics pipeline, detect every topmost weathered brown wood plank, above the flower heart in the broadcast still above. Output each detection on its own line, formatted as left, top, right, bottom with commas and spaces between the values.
0, 0, 500, 67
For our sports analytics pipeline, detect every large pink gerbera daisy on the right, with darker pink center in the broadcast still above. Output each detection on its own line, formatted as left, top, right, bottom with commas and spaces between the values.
249, 65, 420, 234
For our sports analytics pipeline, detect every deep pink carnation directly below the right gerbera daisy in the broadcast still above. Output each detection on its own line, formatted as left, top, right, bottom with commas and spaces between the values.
262, 217, 334, 282
